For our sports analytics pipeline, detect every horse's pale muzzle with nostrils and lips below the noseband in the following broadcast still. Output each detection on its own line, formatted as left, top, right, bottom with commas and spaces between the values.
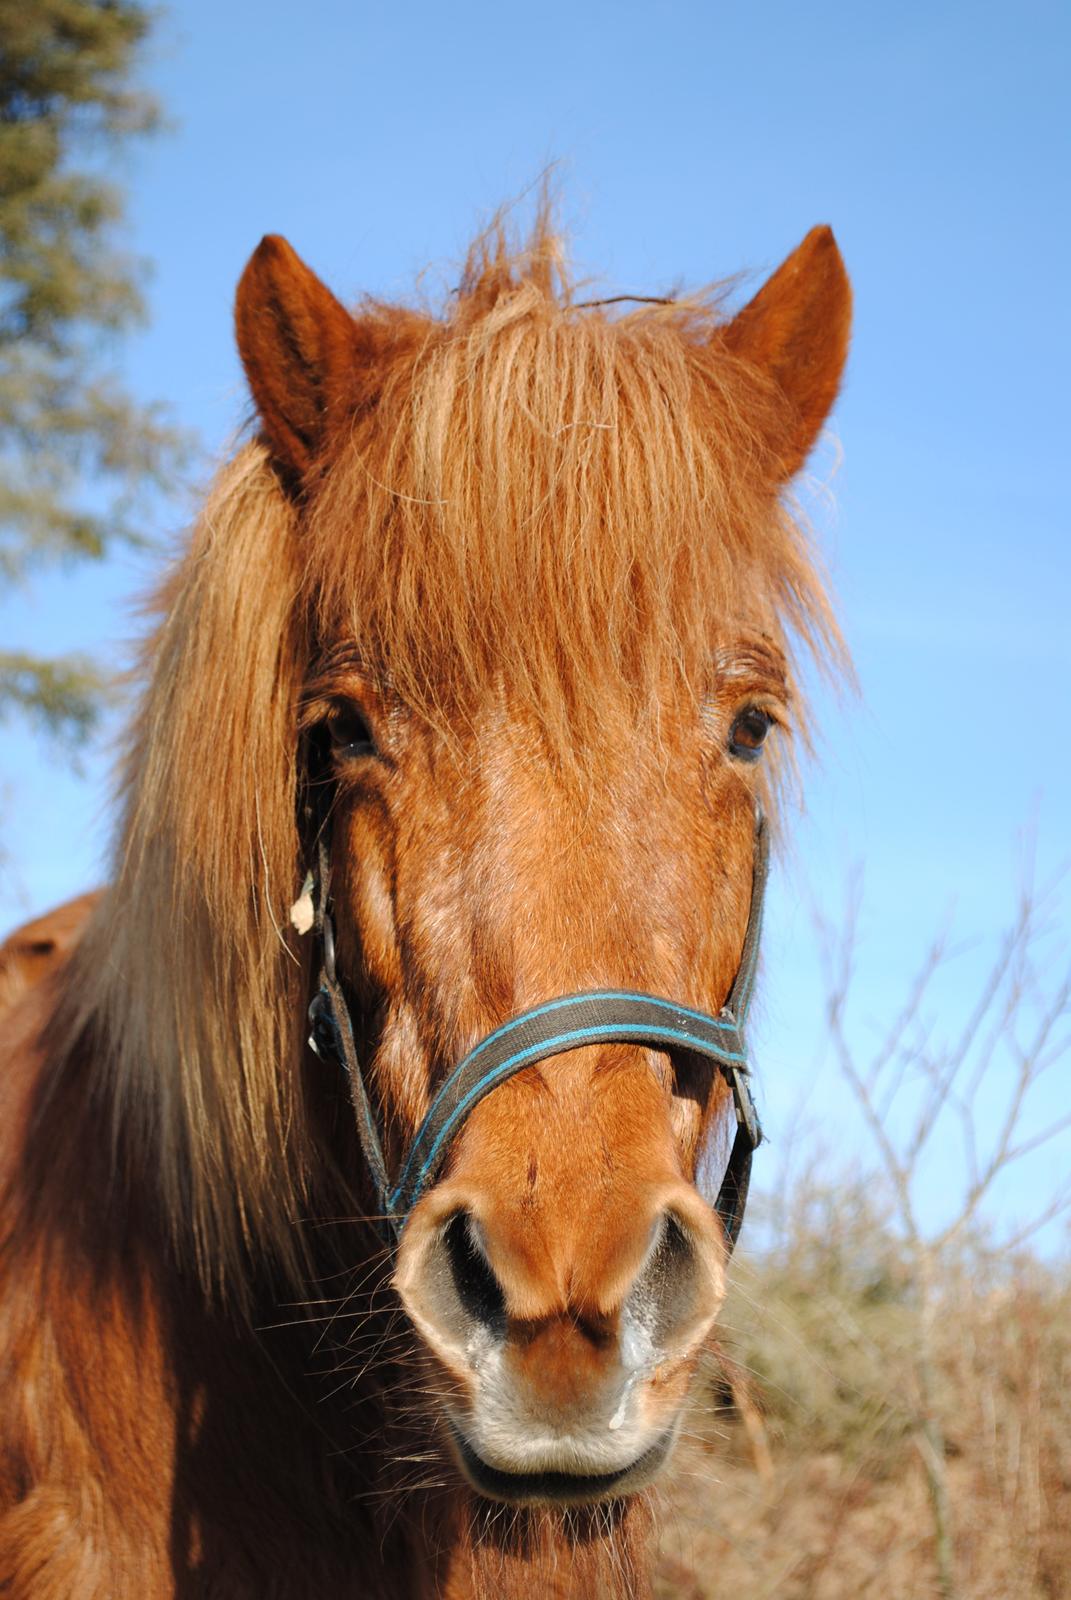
395, 1182, 724, 1504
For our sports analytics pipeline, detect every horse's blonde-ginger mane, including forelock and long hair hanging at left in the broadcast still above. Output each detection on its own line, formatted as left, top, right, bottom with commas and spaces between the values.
50, 218, 837, 1294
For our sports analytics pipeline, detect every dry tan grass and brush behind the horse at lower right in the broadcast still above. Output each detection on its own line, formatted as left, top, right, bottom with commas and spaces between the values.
656, 1186, 1071, 1600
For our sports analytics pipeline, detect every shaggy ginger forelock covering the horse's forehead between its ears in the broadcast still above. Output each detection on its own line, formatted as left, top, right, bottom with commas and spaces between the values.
306, 218, 839, 755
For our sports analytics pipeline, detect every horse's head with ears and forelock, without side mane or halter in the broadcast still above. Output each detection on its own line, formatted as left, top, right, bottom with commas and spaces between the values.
220, 216, 848, 1501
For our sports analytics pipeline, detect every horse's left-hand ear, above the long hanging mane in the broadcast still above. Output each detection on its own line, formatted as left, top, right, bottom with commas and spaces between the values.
234, 234, 360, 477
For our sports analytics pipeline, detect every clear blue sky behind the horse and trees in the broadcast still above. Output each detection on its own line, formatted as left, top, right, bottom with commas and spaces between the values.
0, 0, 1071, 1248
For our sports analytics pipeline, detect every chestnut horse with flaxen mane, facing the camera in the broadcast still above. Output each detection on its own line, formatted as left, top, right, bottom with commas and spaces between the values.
0, 218, 850, 1600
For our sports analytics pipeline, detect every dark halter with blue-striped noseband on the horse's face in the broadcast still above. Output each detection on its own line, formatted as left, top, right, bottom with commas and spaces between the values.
309, 806, 768, 1251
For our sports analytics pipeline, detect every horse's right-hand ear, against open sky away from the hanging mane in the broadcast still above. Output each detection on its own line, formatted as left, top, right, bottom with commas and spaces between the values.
720, 227, 852, 478
